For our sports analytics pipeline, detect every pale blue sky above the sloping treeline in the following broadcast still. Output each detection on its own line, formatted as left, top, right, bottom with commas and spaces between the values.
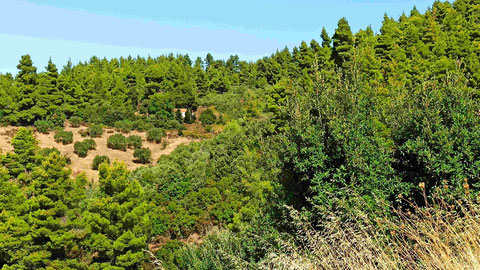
0, 0, 433, 74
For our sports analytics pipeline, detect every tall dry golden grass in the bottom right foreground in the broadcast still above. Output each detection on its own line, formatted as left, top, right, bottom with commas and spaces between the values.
260, 198, 480, 270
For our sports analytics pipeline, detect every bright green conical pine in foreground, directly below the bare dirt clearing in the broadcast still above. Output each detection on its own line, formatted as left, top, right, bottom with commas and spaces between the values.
84, 162, 152, 269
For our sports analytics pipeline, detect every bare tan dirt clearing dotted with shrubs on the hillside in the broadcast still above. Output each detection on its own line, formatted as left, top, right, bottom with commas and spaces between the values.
0, 126, 194, 181
